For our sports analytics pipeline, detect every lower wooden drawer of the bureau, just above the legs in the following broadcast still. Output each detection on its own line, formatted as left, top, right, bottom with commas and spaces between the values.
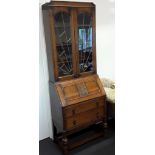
64, 106, 104, 130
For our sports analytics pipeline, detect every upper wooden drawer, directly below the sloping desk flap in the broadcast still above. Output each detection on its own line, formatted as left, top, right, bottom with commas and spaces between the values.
64, 98, 104, 118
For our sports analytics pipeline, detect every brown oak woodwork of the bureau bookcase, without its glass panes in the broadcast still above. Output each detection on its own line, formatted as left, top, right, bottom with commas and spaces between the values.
42, 1, 107, 154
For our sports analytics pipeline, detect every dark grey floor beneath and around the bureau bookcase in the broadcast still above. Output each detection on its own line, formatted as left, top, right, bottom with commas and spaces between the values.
39, 121, 115, 155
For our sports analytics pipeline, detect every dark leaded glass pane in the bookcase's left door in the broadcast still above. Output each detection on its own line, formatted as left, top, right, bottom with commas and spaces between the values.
55, 12, 73, 76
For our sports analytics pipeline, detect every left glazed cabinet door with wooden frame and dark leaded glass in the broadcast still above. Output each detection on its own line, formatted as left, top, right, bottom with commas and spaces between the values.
50, 7, 75, 81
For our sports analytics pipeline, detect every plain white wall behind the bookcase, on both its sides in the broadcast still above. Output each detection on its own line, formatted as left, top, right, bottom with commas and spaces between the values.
39, 0, 115, 140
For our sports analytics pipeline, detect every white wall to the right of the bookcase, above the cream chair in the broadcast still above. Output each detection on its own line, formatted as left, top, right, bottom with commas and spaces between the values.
97, 0, 115, 80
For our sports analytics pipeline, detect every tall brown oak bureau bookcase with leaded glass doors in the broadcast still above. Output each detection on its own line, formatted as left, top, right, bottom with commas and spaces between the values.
42, 1, 107, 153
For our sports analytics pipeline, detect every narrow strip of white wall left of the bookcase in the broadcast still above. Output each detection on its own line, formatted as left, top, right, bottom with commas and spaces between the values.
39, 2, 53, 140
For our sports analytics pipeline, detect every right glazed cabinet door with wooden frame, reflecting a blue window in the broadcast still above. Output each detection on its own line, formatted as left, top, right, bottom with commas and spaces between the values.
75, 8, 96, 76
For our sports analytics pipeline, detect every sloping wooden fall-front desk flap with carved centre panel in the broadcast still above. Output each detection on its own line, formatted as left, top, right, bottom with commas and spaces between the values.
55, 75, 105, 107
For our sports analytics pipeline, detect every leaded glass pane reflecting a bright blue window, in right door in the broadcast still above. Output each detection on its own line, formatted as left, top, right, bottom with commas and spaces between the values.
77, 12, 93, 72
